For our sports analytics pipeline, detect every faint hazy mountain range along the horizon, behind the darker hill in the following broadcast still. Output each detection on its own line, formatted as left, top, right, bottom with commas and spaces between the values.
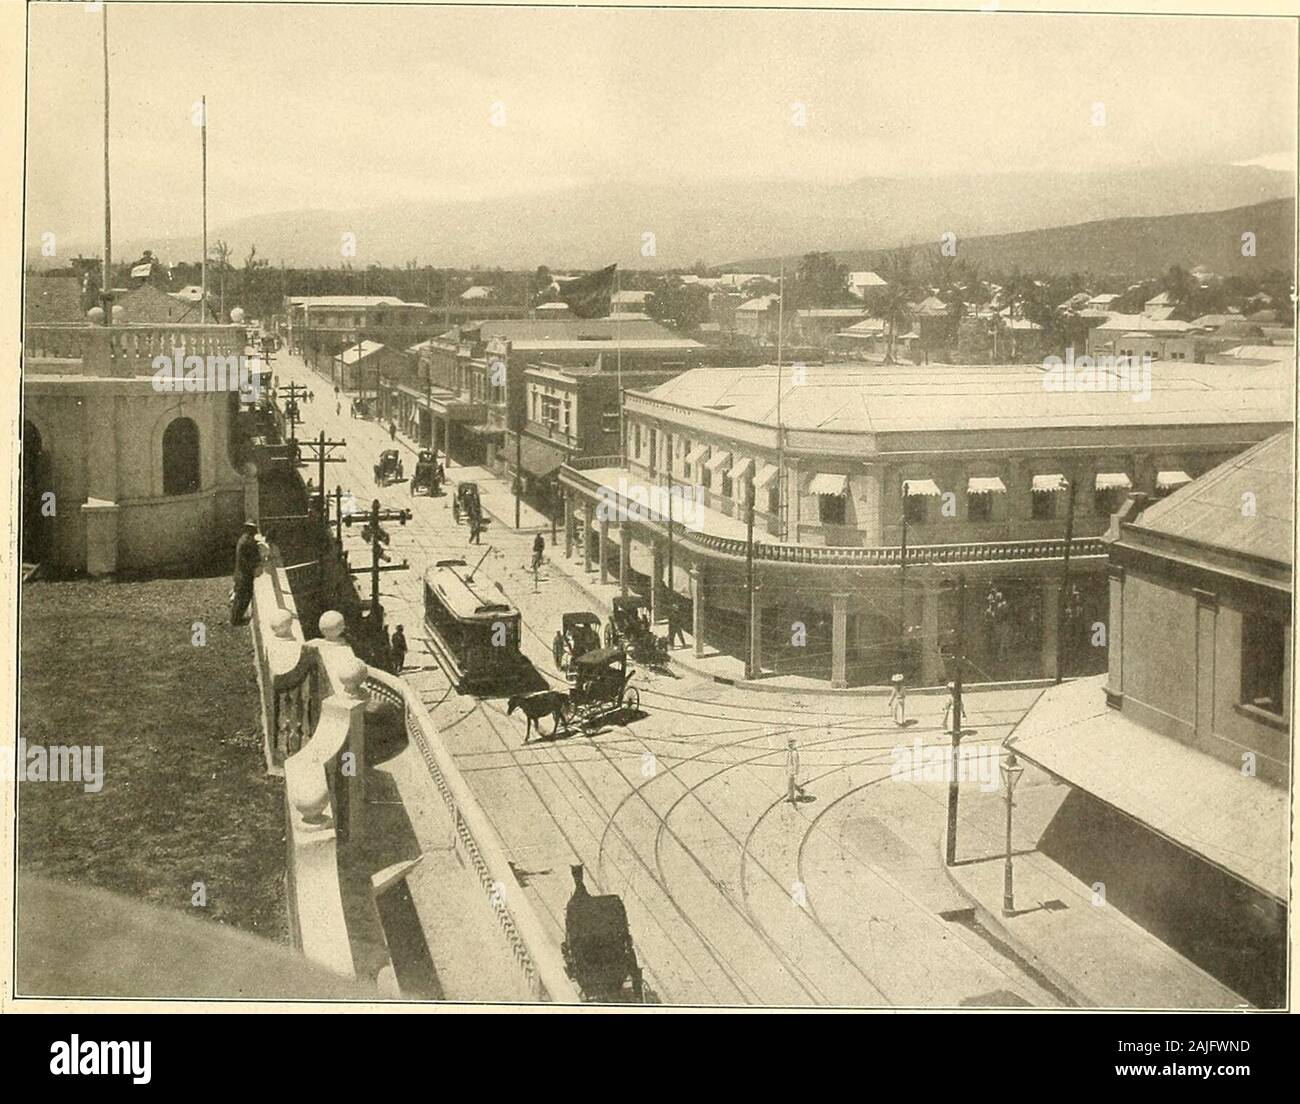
30, 165, 1295, 269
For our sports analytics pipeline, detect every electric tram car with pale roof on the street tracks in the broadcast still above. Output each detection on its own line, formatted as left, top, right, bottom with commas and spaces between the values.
424, 559, 527, 689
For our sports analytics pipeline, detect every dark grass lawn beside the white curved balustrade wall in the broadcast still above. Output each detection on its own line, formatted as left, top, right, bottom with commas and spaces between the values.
18, 576, 289, 943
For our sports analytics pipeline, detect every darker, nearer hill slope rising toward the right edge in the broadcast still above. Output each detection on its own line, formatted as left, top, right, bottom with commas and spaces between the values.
735, 199, 1296, 278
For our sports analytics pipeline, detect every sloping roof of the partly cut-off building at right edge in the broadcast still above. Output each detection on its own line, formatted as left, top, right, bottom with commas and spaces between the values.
1136, 429, 1295, 564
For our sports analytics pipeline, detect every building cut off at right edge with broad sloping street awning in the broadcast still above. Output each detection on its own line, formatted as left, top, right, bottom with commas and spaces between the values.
1008, 430, 1295, 1006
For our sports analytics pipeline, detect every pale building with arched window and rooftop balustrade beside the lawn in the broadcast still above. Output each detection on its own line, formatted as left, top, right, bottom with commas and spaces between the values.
22, 325, 257, 575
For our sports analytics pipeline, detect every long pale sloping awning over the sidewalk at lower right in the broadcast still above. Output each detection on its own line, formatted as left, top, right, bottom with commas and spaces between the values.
1006, 675, 1290, 901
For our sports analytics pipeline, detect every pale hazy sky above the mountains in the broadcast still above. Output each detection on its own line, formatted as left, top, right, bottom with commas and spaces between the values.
27, 3, 1296, 250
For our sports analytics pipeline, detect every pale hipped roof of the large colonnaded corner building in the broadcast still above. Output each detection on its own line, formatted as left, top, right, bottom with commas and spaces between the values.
631, 361, 1294, 433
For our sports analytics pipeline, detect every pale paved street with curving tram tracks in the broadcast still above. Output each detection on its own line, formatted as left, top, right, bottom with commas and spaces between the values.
284, 352, 1061, 1006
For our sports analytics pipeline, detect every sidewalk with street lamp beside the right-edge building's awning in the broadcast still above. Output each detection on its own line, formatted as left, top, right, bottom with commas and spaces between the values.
940, 766, 1251, 1009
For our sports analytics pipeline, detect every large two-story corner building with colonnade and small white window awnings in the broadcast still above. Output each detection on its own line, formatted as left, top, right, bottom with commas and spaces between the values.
560, 363, 1292, 685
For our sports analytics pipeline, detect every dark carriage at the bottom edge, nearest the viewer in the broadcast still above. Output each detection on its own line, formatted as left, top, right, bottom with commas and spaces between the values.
560, 866, 645, 1004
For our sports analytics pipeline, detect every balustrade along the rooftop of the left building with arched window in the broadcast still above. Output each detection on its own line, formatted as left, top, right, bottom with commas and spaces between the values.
22, 324, 247, 380
